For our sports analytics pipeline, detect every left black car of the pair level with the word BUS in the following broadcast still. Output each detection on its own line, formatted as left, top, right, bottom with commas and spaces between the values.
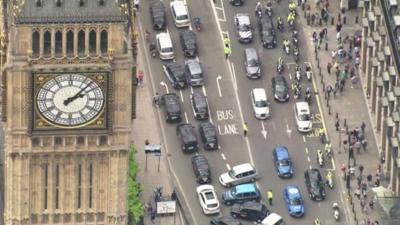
162, 93, 182, 123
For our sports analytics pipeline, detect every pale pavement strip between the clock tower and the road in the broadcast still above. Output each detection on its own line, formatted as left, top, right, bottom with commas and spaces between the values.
132, 52, 182, 225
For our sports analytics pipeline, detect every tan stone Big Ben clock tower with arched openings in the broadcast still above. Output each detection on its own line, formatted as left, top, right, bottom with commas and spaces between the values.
2, 0, 135, 225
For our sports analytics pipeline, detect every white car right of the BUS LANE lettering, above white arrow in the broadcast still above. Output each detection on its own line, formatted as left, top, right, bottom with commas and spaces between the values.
250, 88, 271, 120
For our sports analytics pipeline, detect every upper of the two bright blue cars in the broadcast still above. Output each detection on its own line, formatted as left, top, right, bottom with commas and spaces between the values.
272, 146, 293, 178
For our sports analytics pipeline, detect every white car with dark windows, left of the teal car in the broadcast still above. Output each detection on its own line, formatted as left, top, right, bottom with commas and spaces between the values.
196, 184, 220, 215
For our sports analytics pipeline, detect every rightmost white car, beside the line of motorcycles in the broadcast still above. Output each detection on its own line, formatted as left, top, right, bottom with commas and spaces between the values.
293, 102, 312, 132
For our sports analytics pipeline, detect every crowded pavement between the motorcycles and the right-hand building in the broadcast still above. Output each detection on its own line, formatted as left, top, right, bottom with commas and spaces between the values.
298, 1, 380, 224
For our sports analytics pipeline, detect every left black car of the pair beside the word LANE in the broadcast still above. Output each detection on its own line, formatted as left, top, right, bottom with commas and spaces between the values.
176, 123, 199, 152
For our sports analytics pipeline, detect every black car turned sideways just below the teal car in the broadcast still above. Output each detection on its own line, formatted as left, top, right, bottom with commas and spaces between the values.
231, 202, 269, 222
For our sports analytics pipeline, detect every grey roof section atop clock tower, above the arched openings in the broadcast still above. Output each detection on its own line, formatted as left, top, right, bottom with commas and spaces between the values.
16, 0, 127, 24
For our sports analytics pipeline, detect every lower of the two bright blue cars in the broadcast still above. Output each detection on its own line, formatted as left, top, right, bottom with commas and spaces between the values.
283, 185, 304, 217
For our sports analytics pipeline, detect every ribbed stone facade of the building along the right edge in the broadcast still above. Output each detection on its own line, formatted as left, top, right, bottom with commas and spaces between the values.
360, 0, 400, 192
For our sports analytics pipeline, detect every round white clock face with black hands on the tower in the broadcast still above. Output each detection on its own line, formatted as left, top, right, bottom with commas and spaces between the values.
36, 74, 105, 128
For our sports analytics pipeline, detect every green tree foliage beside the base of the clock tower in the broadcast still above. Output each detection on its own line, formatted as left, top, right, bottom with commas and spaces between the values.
128, 146, 144, 225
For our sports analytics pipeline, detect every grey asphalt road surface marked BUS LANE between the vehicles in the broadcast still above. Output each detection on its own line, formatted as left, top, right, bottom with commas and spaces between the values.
139, 0, 348, 225
